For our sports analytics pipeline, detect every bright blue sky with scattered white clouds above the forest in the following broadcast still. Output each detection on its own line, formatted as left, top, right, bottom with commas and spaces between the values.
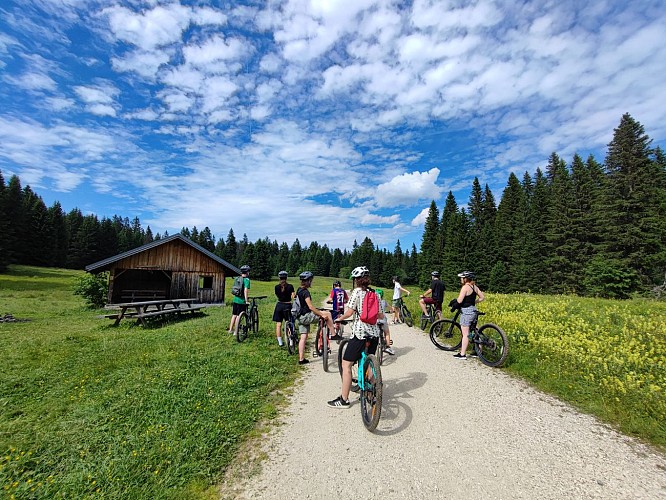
0, 0, 666, 250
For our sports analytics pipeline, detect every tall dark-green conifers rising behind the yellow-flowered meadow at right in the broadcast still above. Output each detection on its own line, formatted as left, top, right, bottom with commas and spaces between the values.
419, 114, 666, 298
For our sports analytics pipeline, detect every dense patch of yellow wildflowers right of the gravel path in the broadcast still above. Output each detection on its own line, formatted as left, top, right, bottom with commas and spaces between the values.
482, 294, 666, 444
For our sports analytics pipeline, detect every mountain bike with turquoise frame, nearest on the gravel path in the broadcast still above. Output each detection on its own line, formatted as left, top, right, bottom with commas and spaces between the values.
338, 332, 384, 432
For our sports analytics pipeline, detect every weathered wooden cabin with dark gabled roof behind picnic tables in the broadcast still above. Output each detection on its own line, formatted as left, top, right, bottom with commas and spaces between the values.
86, 234, 241, 304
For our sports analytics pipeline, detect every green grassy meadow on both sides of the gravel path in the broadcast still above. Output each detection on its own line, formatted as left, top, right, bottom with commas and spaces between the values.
0, 266, 666, 499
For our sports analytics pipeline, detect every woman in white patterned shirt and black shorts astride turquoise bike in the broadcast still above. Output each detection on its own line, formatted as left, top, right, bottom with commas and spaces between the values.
328, 266, 384, 408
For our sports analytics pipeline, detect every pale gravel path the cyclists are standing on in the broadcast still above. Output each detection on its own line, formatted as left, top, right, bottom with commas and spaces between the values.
221, 325, 666, 500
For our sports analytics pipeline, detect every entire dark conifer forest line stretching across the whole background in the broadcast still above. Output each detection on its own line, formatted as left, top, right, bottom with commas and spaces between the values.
0, 114, 666, 298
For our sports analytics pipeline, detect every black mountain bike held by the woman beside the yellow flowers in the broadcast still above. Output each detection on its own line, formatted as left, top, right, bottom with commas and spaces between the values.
430, 311, 509, 367
